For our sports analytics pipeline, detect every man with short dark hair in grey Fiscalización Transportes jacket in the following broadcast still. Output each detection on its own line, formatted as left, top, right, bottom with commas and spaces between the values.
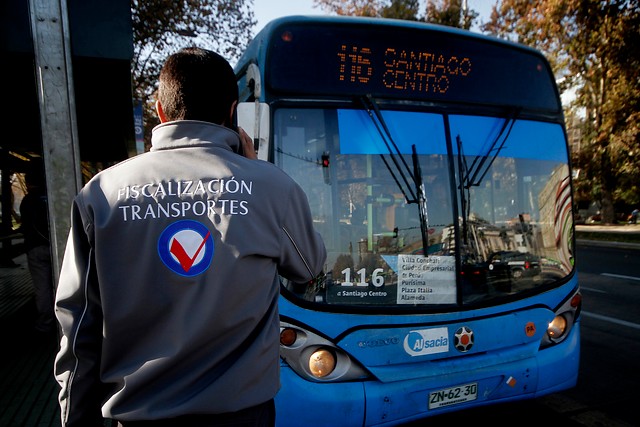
55, 48, 326, 427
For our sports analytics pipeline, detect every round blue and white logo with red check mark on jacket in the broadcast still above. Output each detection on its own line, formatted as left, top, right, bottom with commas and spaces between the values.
158, 220, 214, 277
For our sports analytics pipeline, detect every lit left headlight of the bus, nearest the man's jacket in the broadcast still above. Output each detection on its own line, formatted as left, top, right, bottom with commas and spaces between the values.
280, 321, 369, 382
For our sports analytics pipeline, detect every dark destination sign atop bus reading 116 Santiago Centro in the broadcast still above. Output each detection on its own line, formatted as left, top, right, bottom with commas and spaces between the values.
265, 23, 560, 112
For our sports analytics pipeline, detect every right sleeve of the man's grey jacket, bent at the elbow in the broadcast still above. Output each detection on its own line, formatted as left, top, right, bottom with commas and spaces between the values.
278, 184, 327, 283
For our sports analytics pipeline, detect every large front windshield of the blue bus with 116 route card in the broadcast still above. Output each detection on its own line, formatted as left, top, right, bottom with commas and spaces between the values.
273, 106, 573, 311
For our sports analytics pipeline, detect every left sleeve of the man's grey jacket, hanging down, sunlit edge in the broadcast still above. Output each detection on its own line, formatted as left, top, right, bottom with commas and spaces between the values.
54, 198, 104, 427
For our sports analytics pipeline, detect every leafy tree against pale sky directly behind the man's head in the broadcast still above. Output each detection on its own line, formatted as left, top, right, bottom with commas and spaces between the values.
131, 0, 256, 149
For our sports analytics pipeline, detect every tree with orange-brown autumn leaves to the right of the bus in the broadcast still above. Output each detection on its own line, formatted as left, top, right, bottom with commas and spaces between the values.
483, 0, 640, 223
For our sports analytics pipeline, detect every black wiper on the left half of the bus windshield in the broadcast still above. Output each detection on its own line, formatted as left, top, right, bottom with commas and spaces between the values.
359, 95, 429, 256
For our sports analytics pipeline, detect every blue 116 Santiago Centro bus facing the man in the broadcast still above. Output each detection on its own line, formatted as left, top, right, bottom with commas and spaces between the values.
235, 16, 581, 426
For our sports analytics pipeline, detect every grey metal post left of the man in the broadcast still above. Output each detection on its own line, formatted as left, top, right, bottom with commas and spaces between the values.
29, 0, 82, 283
